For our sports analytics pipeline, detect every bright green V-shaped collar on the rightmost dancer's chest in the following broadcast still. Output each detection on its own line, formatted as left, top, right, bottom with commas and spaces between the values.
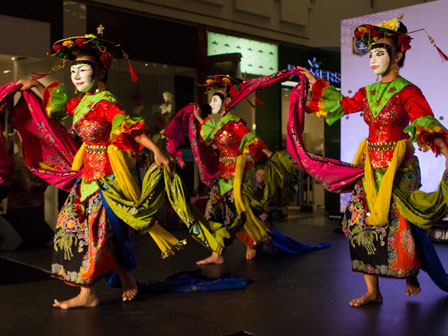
366, 77, 411, 118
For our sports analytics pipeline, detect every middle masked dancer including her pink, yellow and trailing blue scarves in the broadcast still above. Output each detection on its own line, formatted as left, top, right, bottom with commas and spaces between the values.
164, 70, 328, 265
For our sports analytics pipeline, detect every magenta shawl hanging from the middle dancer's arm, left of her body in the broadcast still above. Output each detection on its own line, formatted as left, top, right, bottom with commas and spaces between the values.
163, 104, 219, 186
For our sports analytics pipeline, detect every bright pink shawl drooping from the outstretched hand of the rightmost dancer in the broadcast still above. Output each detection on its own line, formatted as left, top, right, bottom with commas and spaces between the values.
286, 75, 364, 193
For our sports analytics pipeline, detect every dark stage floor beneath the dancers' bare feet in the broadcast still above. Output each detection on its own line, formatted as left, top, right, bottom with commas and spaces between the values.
0, 211, 448, 336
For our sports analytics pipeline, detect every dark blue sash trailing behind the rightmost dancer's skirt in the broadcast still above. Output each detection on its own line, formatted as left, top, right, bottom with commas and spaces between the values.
411, 225, 448, 292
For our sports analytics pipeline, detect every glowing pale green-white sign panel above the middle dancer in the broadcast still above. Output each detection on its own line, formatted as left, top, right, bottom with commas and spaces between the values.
207, 32, 278, 75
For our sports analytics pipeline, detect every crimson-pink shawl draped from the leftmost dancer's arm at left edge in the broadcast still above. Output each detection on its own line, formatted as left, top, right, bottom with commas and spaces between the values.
0, 82, 81, 191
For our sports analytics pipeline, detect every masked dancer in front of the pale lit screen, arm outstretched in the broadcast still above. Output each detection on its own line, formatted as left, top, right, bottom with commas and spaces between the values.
296, 19, 448, 307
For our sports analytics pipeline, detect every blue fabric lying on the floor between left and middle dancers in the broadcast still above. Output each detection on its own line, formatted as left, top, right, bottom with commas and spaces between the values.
139, 269, 251, 294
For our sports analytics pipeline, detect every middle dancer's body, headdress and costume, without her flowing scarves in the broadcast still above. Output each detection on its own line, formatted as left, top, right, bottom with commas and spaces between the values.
194, 76, 272, 265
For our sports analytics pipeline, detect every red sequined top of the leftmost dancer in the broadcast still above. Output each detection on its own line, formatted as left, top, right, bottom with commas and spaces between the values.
66, 97, 145, 182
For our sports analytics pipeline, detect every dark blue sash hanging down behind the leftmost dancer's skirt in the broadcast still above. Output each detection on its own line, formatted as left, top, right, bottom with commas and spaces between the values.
100, 190, 137, 288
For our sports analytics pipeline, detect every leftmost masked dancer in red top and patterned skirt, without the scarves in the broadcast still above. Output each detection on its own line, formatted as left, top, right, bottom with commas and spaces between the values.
17, 30, 177, 309
